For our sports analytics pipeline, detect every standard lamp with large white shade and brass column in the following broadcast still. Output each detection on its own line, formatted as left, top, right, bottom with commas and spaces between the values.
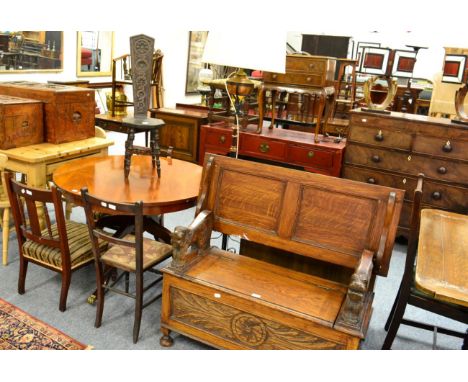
202, 30, 286, 157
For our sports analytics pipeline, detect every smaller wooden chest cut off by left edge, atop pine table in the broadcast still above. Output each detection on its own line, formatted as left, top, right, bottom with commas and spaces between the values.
0, 95, 44, 150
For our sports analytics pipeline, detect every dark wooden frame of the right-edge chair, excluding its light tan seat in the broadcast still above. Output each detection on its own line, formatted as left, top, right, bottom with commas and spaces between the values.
382, 176, 468, 349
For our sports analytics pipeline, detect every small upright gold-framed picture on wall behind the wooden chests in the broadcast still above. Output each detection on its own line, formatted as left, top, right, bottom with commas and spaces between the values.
76, 31, 114, 77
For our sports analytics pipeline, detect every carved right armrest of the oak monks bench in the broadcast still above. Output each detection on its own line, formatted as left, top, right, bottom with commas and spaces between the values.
337, 249, 374, 337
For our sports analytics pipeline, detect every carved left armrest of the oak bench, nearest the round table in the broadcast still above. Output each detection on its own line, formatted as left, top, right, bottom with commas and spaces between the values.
171, 210, 213, 272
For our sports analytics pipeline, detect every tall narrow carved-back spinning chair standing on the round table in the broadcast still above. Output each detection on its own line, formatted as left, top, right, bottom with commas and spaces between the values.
122, 35, 164, 178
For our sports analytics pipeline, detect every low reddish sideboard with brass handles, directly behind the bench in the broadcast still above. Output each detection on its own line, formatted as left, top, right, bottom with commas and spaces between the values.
199, 122, 346, 176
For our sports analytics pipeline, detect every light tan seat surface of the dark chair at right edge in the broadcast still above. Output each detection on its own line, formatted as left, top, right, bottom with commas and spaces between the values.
415, 209, 468, 306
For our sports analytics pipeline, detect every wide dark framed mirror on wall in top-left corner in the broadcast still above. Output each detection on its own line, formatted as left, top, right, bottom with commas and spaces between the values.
0, 31, 63, 73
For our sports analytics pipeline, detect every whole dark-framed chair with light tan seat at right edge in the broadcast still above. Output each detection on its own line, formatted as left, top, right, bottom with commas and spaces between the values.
382, 176, 468, 349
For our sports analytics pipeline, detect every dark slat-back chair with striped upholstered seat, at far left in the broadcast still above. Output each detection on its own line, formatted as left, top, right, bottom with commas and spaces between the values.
5, 173, 100, 312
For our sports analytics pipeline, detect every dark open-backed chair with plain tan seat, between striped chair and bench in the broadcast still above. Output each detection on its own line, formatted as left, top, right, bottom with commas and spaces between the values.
81, 189, 172, 343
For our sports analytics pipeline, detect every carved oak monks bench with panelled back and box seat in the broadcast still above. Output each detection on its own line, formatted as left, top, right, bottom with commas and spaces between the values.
160, 155, 404, 349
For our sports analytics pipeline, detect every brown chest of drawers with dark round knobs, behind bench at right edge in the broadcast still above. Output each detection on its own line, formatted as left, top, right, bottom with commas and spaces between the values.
342, 109, 468, 236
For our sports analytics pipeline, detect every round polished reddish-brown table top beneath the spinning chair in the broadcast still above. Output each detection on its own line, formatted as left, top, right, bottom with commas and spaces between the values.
53, 155, 203, 215
